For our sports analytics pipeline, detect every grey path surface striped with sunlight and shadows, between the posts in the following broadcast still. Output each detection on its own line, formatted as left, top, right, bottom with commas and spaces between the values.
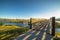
14, 22, 53, 40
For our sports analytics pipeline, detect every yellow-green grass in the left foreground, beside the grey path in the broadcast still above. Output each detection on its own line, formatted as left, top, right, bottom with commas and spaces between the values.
0, 26, 28, 40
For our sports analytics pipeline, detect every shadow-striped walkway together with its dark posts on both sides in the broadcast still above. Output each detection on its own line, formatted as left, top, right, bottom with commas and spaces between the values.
14, 17, 55, 40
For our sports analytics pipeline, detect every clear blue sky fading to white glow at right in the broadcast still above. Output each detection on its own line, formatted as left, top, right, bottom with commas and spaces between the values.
0, 0, 60, 19
